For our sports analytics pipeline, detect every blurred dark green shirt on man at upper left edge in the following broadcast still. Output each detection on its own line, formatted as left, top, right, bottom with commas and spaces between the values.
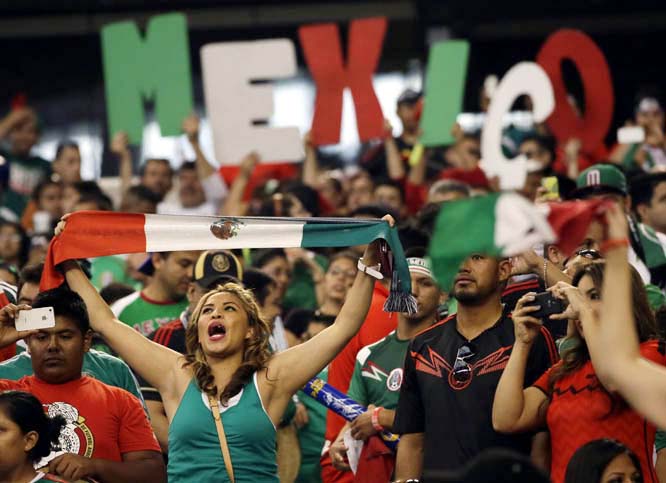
0, 150, 51, 219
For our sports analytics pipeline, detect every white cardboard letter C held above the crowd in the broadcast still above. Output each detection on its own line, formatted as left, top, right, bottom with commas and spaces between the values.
481, 62, 555, 190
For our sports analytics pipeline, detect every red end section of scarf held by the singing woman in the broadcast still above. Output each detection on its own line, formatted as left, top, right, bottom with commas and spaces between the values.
39, 211, 146, 290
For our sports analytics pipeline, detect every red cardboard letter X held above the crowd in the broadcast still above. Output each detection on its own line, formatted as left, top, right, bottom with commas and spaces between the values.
298, 17, 386, 145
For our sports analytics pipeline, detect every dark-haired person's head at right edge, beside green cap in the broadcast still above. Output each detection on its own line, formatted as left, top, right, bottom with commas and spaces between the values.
631, 173, 666, 234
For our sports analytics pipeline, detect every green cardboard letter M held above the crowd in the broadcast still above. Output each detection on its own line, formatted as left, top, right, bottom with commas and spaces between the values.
102, 13, 193, 143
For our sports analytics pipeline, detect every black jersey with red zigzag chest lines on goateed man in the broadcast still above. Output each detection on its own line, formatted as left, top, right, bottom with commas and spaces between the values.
393, 312, 557, 473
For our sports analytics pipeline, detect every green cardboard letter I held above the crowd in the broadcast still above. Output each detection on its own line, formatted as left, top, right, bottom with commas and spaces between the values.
421, 40, 469, 146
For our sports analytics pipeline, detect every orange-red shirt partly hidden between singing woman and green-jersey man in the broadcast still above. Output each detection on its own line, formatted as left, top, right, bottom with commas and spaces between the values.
322, 282, 398, 482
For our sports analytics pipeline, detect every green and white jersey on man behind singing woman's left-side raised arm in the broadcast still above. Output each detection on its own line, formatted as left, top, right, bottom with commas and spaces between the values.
111, 292, 188, 336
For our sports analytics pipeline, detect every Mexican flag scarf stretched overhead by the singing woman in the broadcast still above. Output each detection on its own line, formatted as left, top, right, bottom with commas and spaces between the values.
40, 211, 416, 312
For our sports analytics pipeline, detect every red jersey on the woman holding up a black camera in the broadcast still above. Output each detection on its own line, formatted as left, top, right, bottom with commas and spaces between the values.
534, 341, 666, 483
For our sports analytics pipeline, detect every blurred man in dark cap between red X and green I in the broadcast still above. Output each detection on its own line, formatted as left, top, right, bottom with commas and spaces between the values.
362, 89, 421, 179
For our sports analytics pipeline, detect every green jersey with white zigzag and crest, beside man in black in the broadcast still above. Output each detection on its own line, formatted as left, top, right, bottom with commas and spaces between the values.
348, 330, 409, 409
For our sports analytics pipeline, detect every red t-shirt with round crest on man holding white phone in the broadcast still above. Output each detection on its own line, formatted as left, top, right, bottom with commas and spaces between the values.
0, 376, 160, 463
